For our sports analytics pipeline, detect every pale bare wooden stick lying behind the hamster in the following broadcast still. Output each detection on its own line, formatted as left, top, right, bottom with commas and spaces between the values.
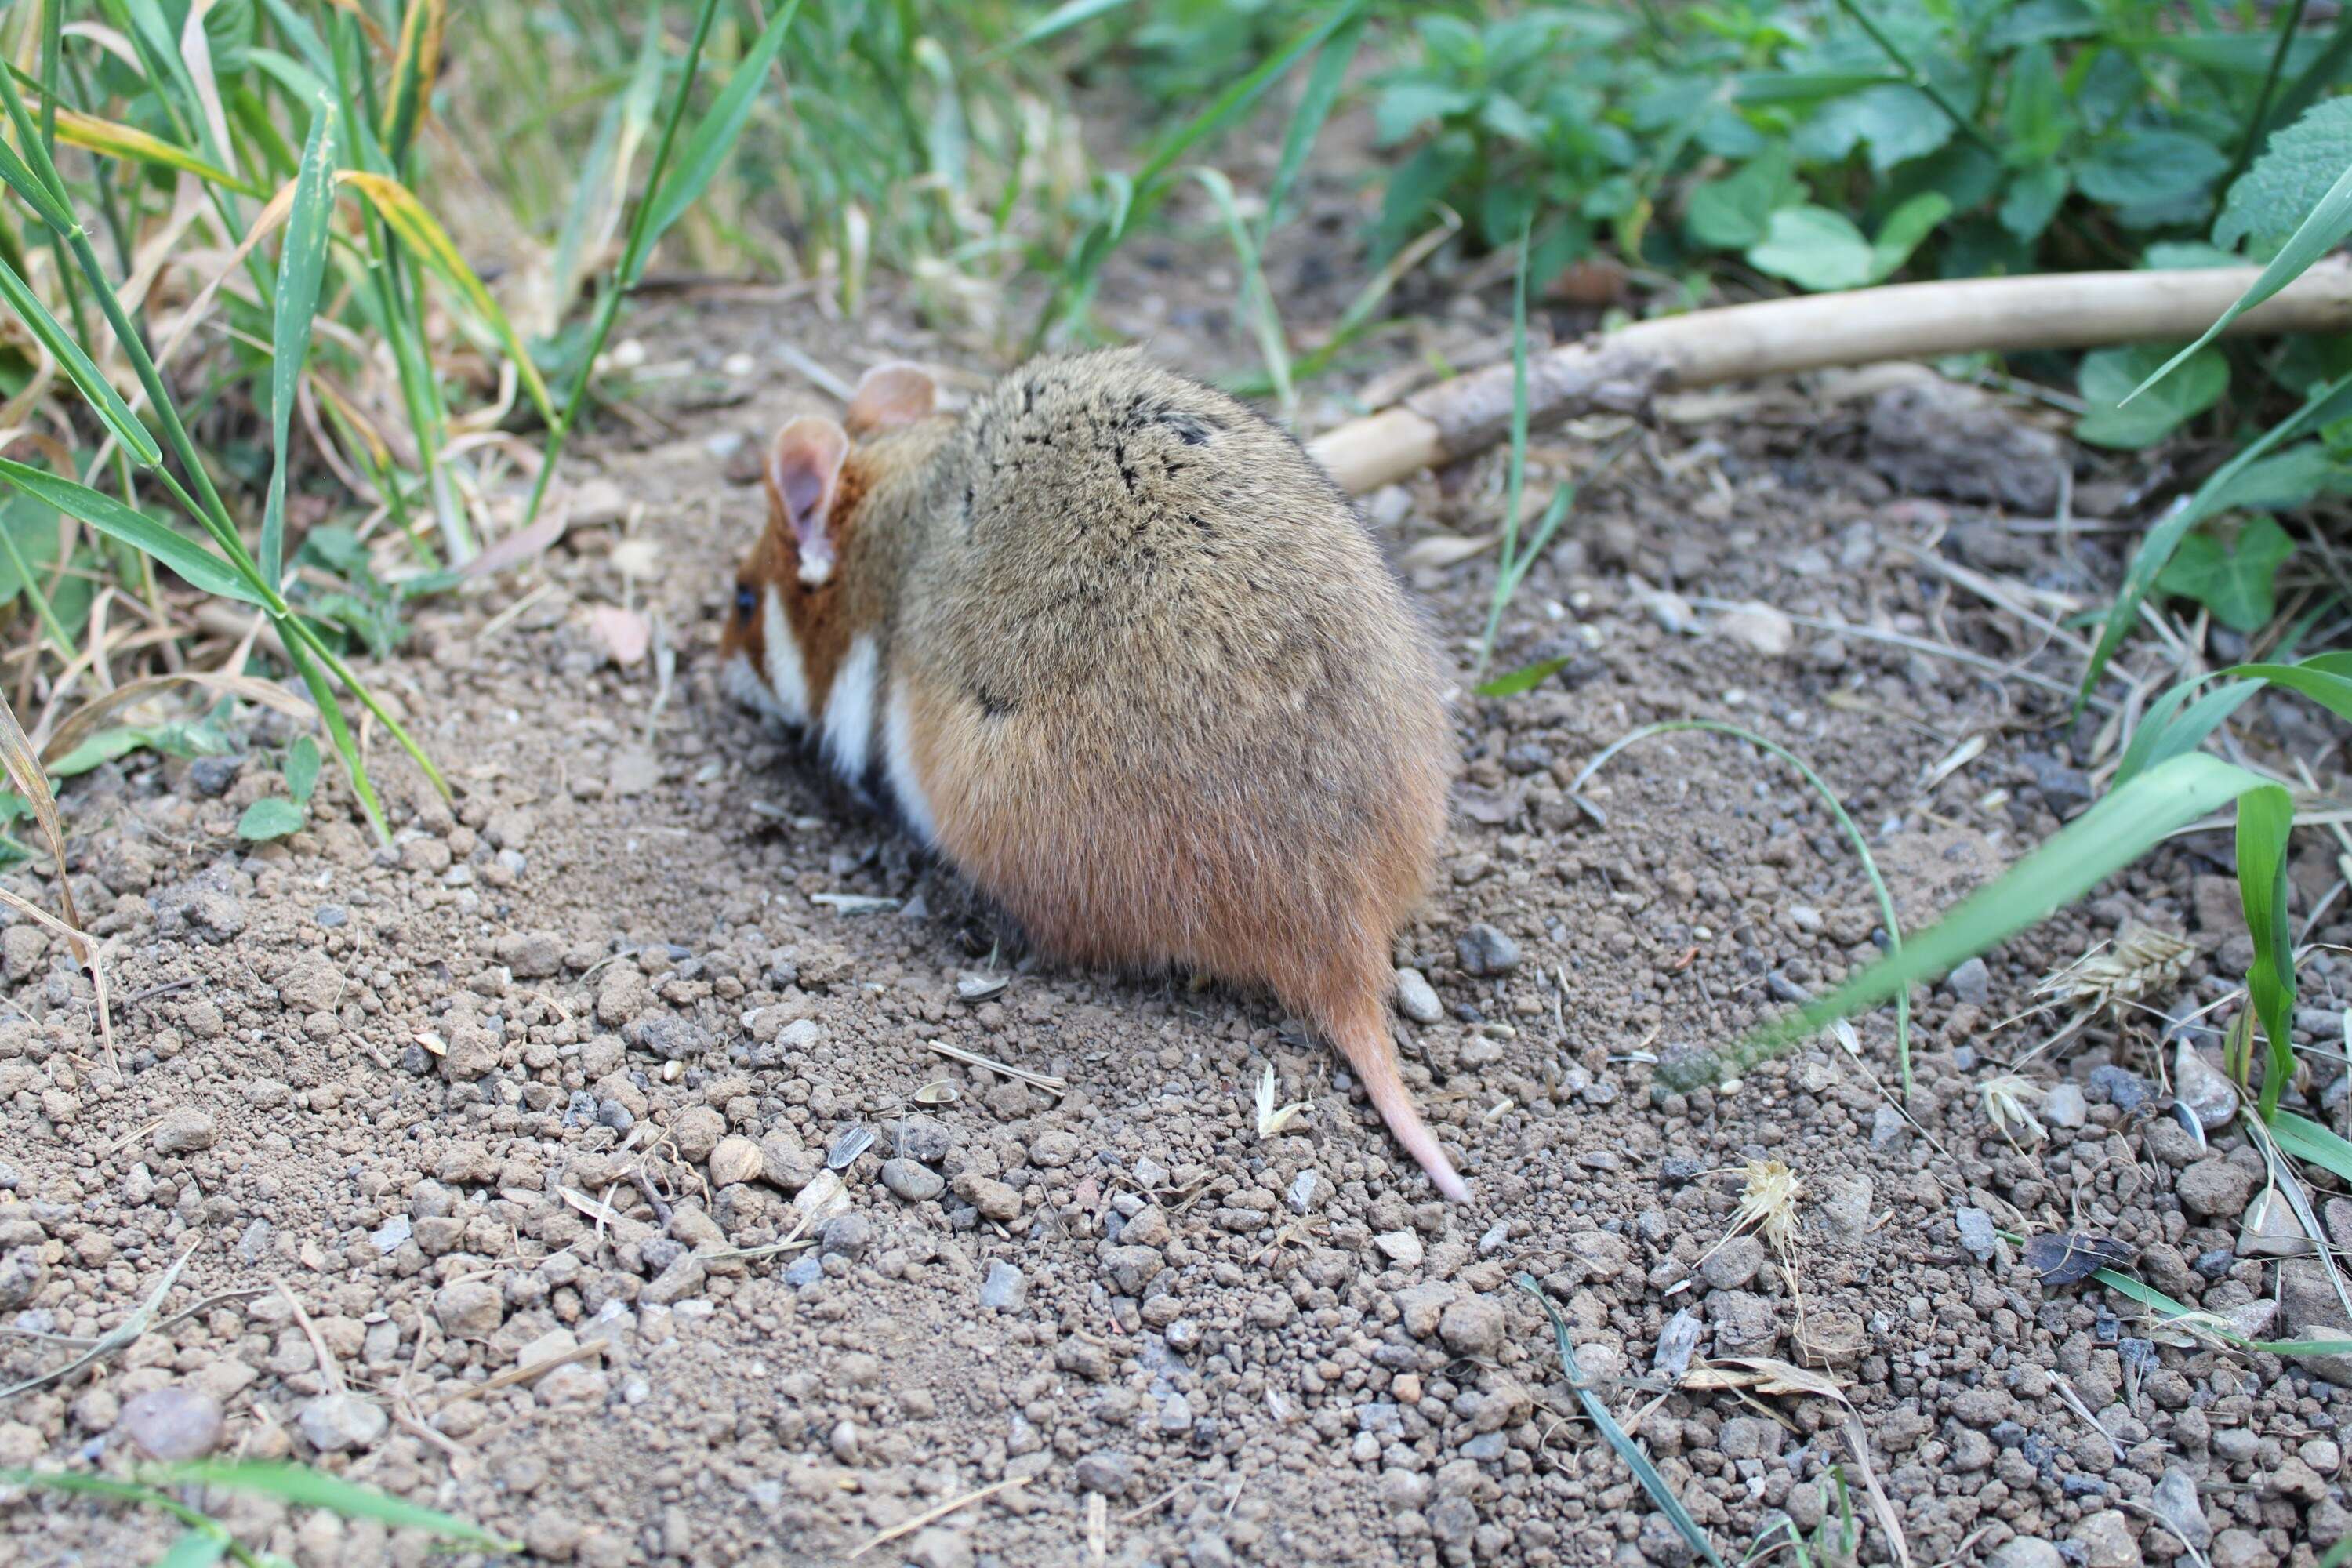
1308, 261, 2352, 496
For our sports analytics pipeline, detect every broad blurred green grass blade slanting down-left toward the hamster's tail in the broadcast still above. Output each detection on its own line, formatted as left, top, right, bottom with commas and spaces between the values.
1693, 753, 2263, 1081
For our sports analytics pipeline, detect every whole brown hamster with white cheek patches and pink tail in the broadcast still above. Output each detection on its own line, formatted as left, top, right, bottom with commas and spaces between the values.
720, 350, 1470, 1201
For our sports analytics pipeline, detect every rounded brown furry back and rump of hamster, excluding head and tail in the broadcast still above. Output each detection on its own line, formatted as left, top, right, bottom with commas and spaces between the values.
891, 353, 1451, 1027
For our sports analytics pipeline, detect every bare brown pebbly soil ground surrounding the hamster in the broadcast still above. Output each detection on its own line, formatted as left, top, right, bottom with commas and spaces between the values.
0, 171, 2352, 1568
